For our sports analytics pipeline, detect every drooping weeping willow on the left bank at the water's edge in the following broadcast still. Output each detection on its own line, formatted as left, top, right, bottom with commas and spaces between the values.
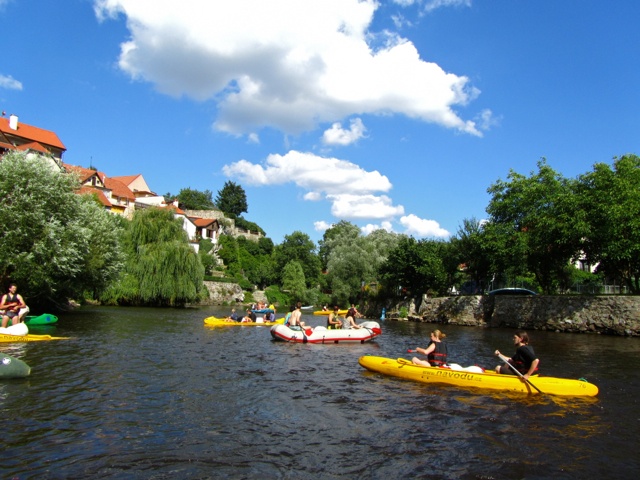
103, 208, 204, 306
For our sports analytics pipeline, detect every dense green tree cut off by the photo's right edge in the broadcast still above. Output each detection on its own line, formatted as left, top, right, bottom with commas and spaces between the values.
578, 155, 640, 294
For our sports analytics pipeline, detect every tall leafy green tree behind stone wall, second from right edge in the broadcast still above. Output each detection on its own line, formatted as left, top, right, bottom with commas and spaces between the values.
487, 159, 584, 293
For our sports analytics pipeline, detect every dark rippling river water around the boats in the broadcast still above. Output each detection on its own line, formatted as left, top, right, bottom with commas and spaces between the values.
0, 307, 640, 479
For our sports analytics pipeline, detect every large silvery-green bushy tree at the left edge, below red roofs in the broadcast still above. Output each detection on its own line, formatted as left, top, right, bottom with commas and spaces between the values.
0, 152, 122, 309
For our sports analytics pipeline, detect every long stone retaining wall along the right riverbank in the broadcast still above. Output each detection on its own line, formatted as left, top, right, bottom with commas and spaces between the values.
400, 295, 640, 336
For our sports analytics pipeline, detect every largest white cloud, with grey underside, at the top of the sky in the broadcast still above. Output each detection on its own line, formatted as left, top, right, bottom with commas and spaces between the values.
94, 0, 481, 136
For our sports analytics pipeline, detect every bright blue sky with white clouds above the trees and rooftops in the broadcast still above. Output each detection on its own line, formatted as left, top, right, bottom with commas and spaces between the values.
0, 0, 640, 243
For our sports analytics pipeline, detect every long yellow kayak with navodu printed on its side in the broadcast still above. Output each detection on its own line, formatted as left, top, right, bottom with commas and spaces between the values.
358, 355, 598, 397
